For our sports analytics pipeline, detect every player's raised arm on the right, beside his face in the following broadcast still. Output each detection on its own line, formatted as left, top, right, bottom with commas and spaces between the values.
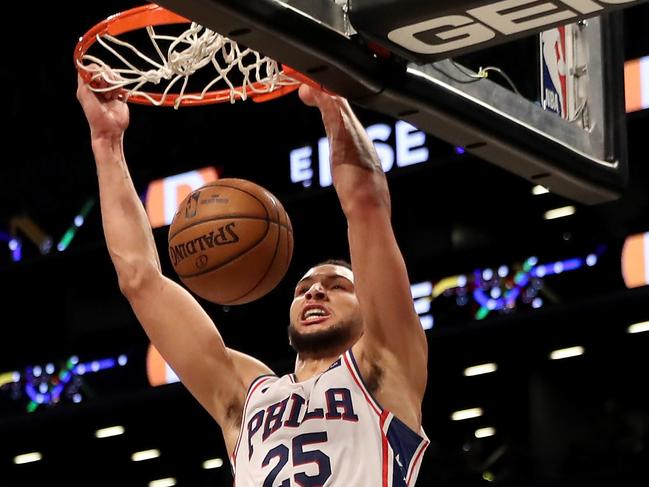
301, 87, 428, 420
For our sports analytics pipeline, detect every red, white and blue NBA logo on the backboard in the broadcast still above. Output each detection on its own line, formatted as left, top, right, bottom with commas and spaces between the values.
540, 25, 574, 120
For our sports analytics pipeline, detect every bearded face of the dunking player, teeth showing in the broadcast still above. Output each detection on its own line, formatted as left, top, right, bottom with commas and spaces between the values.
289, 264, 363, 353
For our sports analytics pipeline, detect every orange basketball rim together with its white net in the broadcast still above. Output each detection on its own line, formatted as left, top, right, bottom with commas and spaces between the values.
74, 4, 301, 108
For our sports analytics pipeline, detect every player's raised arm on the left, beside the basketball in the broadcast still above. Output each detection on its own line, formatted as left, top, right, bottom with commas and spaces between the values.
77, 74, 270, 447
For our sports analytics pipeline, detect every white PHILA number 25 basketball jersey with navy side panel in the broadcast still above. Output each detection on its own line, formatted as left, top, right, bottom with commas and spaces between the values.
231, 350, 429, 487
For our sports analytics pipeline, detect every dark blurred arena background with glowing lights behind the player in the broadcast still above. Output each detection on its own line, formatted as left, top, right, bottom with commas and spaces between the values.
0, 0, 649, 487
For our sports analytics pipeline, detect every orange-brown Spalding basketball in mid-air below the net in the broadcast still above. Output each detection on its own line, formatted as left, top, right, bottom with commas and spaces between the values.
168, 178, 293, 305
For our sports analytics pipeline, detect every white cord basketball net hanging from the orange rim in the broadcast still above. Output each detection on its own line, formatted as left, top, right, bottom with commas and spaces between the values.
80, 22, 299, 108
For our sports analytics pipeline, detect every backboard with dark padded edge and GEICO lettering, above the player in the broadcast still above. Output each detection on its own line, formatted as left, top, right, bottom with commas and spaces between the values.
149, 0, 643, 204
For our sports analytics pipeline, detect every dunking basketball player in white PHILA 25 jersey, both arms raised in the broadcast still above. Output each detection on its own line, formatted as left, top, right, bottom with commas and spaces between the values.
77, 74, 428, 487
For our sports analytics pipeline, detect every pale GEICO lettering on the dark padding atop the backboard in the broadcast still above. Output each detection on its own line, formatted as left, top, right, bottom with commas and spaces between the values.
388, 0, 638, 54
